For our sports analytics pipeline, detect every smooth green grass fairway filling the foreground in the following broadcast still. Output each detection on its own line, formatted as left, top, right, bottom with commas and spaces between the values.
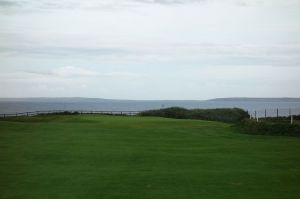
0, 115, 300, 199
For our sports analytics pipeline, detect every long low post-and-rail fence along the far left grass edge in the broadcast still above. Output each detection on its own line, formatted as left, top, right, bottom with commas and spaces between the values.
0, 110, 140, 118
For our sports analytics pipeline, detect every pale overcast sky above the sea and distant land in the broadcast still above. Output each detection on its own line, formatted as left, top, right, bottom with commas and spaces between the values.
0, 0, 300, 100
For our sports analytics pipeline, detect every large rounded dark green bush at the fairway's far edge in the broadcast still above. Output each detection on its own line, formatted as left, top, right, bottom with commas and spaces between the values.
139, 107, 249, 122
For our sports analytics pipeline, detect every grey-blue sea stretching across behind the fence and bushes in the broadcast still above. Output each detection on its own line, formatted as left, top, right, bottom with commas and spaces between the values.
0, 98, 300, 117
